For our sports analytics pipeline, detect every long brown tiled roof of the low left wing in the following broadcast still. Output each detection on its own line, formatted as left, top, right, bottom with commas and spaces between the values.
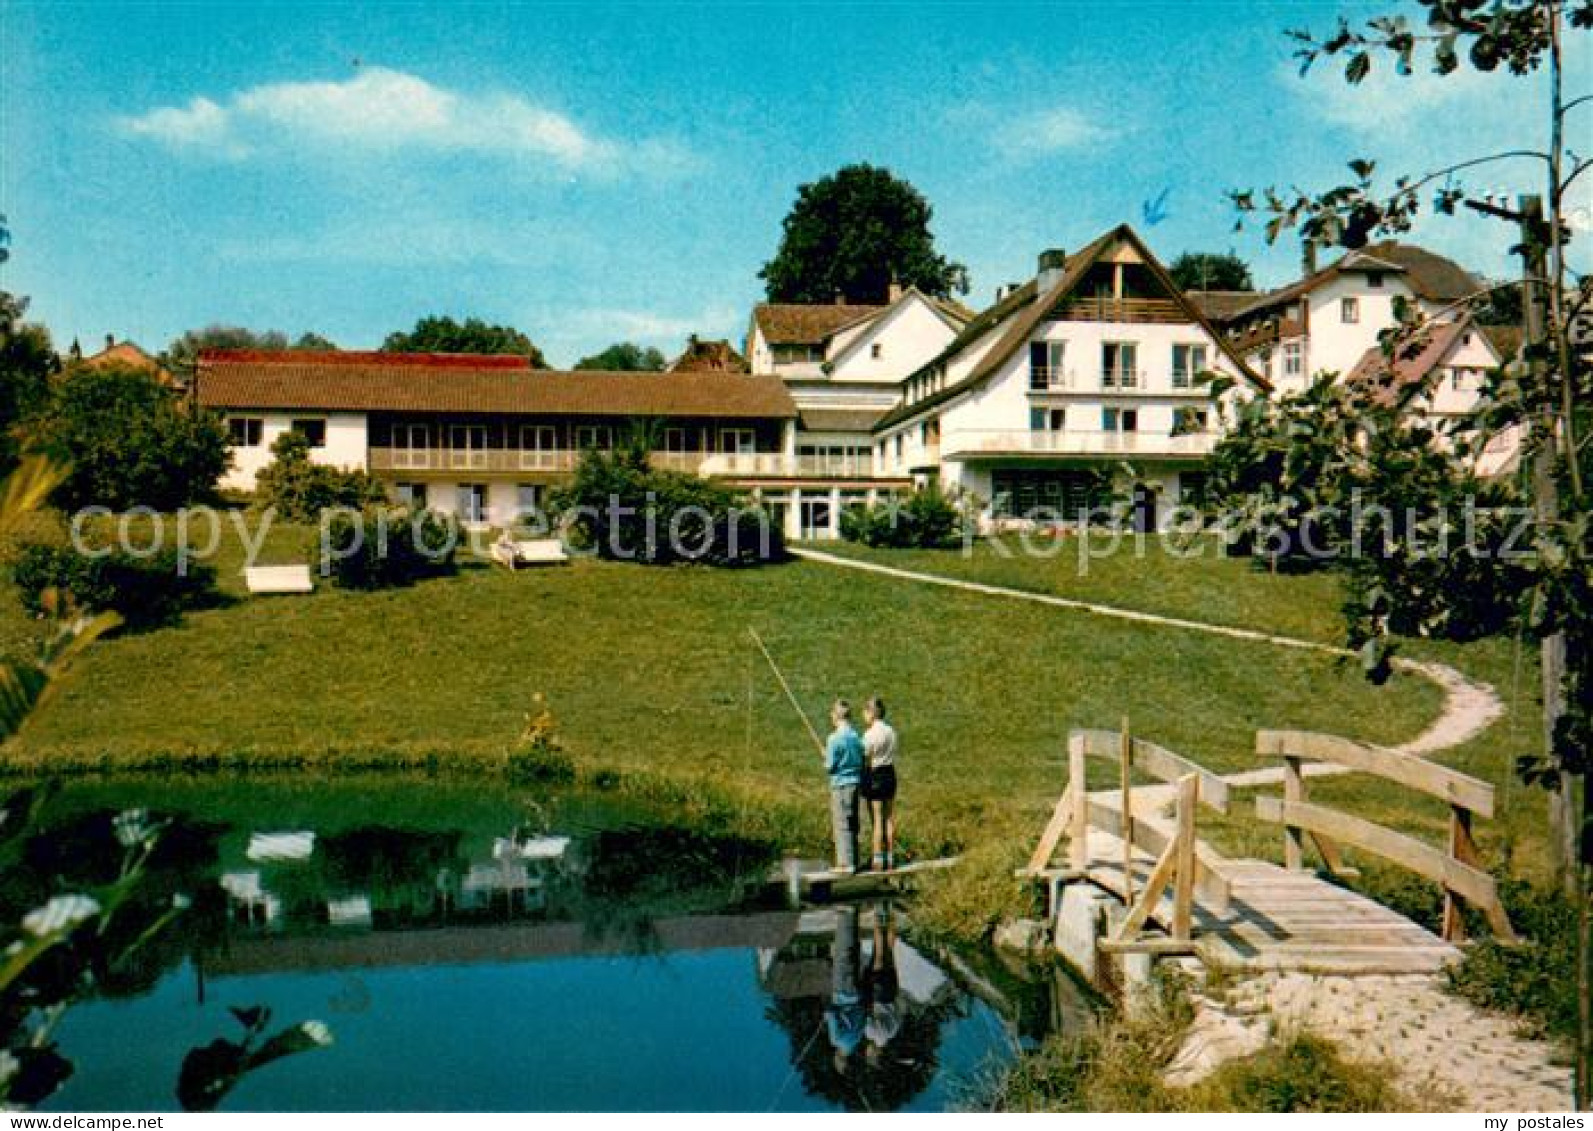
198, 350, 797, 419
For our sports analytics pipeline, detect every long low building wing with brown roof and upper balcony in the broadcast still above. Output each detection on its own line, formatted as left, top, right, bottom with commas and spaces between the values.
194, 350, 798, 526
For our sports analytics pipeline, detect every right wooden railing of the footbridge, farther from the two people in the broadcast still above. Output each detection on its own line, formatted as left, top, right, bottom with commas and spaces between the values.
1255, 731, 1515, 941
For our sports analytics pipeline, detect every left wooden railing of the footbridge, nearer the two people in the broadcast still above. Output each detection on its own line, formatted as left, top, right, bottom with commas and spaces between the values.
1020, 720, 1231, 953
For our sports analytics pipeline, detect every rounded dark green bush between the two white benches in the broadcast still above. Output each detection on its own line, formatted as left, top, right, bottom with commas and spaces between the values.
322, 507, 459, 589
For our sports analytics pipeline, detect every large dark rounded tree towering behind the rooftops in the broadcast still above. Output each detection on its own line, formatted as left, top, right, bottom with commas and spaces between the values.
758, 164, 969, 303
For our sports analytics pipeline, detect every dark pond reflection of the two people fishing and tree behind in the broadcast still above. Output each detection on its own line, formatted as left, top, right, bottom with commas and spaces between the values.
761, 902, 965, 1110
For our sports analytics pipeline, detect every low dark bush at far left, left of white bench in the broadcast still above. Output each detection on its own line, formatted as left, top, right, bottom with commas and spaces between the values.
11, 543, 217, 629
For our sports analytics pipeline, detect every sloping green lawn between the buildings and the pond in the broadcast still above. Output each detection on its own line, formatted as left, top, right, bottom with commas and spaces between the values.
3, 530, 1471, 866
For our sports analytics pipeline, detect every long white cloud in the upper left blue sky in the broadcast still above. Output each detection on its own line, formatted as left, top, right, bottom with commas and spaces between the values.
118, 67, 682, 170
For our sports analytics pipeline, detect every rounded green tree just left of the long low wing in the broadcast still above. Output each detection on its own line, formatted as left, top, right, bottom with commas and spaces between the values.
37, 365, 229, 511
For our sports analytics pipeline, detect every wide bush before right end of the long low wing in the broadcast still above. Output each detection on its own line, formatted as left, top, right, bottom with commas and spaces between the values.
553, 441, 785, 567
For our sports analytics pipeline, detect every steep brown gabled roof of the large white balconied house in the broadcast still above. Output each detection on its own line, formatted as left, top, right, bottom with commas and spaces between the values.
875, 223, 1270, 430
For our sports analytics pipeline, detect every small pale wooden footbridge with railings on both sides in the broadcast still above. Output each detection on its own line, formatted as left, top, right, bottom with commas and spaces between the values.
1020, 722, 1515, 975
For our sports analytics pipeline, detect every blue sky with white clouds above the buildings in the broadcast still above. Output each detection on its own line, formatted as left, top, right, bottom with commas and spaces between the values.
0, 0, 1593, 365
